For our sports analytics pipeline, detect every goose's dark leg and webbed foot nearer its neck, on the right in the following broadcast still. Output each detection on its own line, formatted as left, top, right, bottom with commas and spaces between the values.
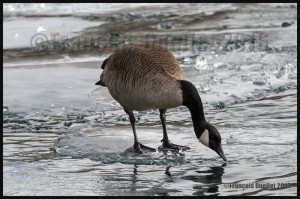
158, 109, 190, 150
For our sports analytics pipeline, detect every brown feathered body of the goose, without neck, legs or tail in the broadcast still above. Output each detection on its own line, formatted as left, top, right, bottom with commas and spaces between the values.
101, 44, 183, 111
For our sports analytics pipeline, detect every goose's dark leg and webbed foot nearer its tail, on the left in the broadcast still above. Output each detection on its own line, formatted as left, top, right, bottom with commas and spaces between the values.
124, 109, 156, 153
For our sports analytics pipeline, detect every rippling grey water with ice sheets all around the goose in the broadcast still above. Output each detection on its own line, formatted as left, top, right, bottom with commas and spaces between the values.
3, 4, 297, 196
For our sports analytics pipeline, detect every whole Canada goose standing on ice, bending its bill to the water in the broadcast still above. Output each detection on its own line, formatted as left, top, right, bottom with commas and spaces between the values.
96, 44, 226, 161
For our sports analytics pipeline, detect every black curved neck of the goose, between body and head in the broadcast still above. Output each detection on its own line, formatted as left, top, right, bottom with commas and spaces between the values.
180, 80, 206, 137
